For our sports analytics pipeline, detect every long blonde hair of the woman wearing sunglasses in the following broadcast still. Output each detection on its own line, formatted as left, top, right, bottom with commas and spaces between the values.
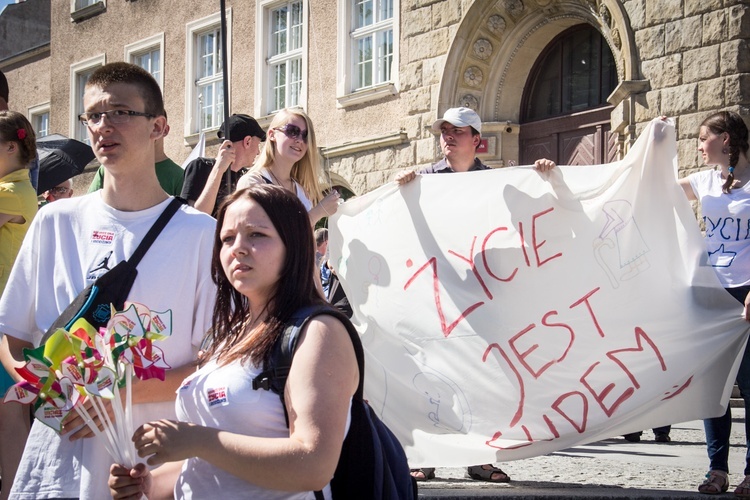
250, 108, 323, 205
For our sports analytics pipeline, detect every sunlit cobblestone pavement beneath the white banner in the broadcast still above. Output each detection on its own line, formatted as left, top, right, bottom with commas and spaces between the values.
419, 408, 746, 500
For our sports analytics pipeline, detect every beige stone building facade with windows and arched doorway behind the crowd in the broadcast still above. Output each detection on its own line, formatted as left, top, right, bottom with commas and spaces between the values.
0, 0, 750, 194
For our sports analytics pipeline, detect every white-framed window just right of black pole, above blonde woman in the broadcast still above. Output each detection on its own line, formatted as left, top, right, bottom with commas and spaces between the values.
255, 0, 307, 115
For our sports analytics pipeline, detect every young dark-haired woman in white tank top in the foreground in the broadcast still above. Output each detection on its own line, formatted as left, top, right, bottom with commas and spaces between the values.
109, 184, 358, 499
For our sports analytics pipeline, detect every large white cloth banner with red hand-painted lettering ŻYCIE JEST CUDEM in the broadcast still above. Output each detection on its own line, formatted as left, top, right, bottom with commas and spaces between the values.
329, 120, 748, 466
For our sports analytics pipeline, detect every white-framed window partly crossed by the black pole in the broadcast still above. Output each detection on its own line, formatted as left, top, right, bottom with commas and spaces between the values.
185, 9, 232, 136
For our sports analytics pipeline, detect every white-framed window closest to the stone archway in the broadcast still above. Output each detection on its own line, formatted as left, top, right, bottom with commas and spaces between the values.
338, 0, 399, 106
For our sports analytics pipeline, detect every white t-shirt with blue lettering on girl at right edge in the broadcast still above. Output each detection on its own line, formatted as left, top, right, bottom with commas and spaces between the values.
688, 170, 750, 288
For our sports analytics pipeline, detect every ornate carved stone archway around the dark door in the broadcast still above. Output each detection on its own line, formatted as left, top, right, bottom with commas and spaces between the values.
437, 0, 646, 166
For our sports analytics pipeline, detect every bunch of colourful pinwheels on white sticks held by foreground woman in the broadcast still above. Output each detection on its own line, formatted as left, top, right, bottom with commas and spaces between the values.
4, 303, 172, 466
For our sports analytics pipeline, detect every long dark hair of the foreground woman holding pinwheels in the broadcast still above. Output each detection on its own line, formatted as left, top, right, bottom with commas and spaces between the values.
200, 184, 323, 365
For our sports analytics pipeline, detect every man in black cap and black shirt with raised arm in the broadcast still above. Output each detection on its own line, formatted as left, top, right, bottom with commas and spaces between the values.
181, 114, 266, 217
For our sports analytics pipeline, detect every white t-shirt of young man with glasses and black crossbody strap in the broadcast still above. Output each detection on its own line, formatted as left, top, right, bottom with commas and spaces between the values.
0, 191, 216, 500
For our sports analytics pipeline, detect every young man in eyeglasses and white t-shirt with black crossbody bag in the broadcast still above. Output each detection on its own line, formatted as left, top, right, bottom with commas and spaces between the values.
0, 62, 216, 500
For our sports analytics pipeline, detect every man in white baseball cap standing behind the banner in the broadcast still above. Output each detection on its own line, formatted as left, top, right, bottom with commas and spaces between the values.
395, 107, 555, 483
